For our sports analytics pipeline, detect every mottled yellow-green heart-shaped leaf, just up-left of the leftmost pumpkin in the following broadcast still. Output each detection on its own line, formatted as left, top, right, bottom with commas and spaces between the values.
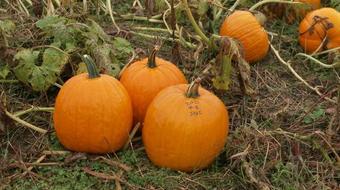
14, 48, 68, 91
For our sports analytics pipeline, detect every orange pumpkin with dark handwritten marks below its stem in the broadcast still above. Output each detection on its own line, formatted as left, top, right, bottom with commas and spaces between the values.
142, 80, 229, 172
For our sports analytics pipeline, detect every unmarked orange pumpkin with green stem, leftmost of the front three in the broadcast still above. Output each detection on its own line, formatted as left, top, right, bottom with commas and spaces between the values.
53, 55, 132, 153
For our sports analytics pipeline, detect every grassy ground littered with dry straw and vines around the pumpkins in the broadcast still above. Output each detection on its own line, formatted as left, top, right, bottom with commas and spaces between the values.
0, 0, 340, 190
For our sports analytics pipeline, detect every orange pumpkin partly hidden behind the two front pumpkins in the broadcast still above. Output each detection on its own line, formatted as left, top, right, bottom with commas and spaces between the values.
120, 46, 187, 122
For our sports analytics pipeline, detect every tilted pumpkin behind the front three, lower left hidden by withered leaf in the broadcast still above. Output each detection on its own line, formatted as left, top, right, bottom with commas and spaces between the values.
220, 11, 269, 62
